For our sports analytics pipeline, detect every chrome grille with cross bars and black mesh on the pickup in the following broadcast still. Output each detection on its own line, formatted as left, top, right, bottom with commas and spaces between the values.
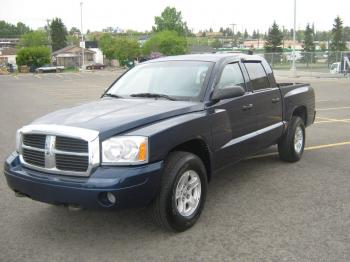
19, 126, 99, 176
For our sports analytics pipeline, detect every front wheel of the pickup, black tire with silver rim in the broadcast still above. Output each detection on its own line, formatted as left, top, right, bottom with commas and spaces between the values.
150, 151, 208, 232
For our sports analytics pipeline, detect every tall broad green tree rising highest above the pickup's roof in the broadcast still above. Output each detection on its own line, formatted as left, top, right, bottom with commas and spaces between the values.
153, 6, 189, 36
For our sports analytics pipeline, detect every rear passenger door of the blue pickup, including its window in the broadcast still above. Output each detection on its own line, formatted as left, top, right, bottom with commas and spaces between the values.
244, 61, 283, 148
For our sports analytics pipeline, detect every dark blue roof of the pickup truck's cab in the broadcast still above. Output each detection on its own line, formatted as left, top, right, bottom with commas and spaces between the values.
146, 53, 264, 63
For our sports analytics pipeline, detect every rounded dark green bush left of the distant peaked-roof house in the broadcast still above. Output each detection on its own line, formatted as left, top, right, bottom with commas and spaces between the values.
16, 46, 51, 67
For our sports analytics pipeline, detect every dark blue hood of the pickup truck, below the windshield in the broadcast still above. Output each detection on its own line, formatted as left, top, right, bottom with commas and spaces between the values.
32, 98, 204, 139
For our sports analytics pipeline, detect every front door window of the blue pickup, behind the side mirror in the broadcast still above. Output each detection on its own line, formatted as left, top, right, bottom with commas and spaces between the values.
218, 63, 245, 88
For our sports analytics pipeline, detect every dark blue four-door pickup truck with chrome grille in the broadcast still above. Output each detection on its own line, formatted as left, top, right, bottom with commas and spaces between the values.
4, 54, 315, 231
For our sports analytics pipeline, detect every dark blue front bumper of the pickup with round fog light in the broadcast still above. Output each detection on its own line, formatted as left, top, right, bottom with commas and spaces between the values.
4, 153, 163, 208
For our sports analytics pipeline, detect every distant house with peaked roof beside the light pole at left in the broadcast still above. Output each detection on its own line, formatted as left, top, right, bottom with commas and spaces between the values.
52, 46, 95, 67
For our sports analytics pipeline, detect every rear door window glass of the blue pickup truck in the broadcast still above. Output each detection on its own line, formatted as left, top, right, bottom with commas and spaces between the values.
244, 62, 270, 90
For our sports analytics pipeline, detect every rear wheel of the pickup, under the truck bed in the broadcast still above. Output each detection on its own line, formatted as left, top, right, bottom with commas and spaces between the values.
278, 116, 305, 162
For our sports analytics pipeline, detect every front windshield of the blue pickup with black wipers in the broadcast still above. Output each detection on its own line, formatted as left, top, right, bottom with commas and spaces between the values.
107, 61, 212, 101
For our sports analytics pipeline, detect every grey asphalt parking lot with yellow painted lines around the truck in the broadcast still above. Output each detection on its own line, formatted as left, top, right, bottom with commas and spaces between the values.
0, 71, 350, 262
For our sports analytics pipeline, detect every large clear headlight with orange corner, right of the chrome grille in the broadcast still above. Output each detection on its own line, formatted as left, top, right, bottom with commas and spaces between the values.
102, 136, 148, 165
